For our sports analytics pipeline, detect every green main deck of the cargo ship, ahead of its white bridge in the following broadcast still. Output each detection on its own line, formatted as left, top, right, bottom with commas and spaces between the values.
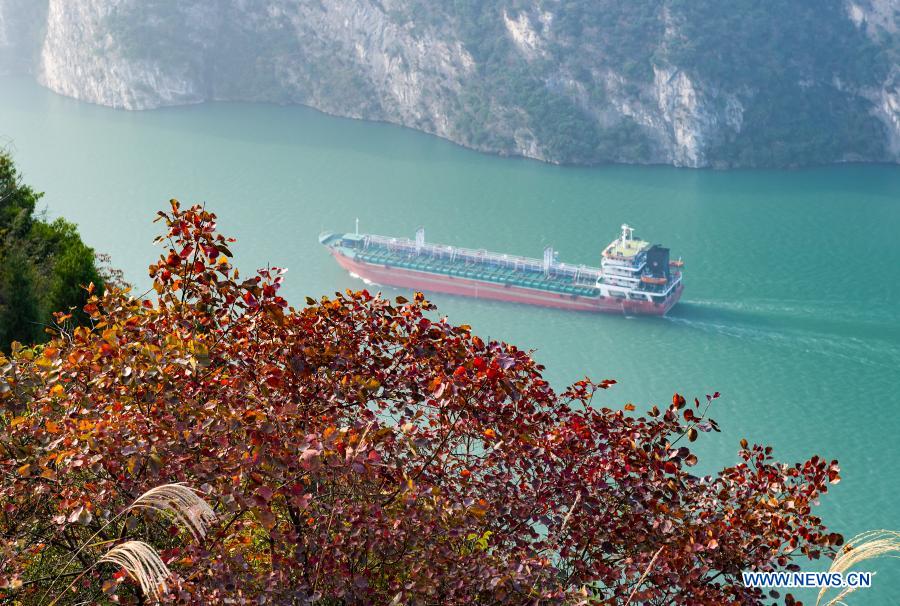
348, 247, 598, 297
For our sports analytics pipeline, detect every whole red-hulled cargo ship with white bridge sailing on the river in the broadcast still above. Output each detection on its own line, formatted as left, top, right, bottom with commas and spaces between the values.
319, 220, 684, 315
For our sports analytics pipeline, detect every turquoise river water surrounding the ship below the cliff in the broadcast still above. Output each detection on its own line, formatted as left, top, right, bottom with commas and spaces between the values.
0, 78, 900, 605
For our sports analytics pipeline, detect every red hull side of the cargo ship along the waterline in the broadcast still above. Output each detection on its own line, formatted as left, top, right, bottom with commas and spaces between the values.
331, 249, 683, 316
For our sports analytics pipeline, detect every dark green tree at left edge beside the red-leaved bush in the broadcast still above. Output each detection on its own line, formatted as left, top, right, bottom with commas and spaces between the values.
0, 153, 104, 350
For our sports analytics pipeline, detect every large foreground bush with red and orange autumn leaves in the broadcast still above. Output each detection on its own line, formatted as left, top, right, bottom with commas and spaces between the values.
0, 201, 842, 606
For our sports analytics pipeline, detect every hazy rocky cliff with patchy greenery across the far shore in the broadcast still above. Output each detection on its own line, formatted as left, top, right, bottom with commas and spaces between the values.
0, 0, 900, 166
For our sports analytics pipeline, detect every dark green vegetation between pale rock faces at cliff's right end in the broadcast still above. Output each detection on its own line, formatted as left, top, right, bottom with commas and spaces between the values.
663, 0, 897, 166
